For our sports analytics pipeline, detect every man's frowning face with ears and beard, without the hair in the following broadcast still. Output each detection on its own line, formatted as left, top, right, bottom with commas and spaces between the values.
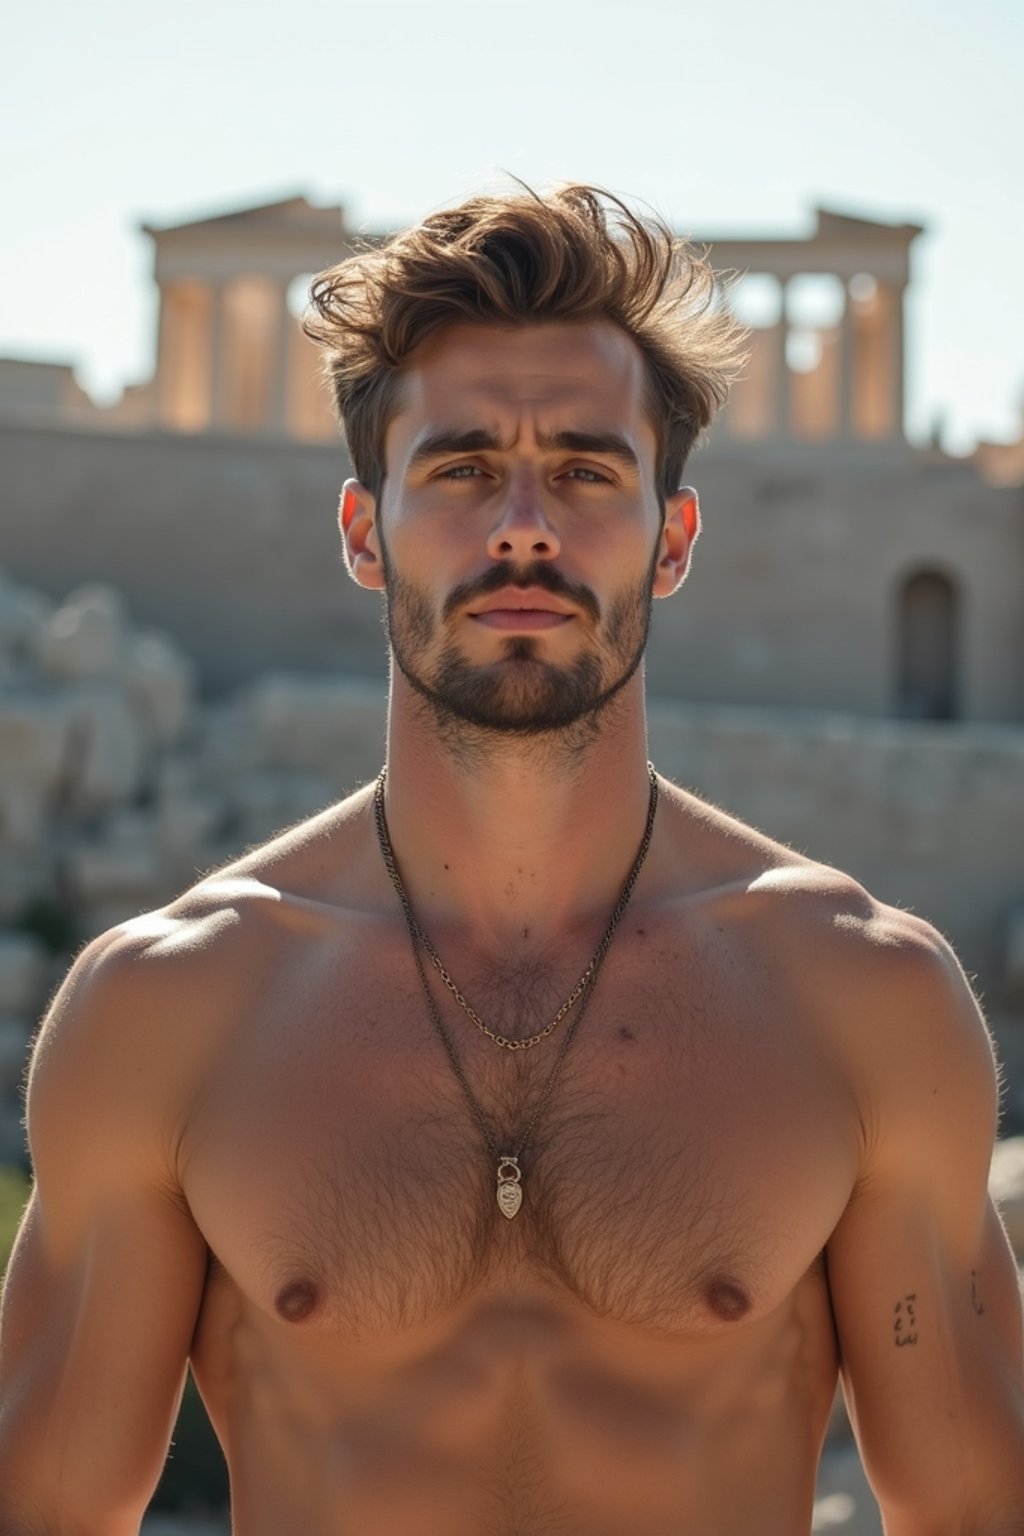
348, 323, 695, 733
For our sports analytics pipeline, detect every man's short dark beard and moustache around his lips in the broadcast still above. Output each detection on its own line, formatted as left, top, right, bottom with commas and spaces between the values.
381, 538, 657, 736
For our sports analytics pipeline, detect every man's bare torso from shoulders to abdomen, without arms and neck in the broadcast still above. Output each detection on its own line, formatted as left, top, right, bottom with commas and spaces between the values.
144, 800, 878, 1536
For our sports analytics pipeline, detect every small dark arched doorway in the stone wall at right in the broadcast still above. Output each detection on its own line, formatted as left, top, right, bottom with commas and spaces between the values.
897, 570, 958, 720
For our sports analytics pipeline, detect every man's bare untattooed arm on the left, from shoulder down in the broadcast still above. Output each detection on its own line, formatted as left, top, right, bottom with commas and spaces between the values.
0, 935, 206, 1536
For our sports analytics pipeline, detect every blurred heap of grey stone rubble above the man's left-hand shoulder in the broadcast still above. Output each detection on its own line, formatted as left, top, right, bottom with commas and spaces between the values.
0, 573, 384, 1161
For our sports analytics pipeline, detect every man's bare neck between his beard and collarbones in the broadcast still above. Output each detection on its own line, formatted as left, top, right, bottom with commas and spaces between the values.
379, 674, 649, 957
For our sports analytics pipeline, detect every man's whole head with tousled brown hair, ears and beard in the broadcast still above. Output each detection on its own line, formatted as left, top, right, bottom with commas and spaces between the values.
300, 187, 742, 734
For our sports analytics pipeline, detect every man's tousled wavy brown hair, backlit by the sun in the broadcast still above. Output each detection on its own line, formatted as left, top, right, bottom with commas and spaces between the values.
302, 183, 746, 496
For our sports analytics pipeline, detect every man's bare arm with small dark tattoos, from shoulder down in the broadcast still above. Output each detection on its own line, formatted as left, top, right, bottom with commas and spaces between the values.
827, 914, 1024, 1536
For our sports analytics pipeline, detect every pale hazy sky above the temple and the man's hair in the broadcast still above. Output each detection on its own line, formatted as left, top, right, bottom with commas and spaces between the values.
0, 0, 1024, 452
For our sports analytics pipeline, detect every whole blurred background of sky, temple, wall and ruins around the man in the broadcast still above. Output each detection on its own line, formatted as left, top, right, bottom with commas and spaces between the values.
0, 0, 1024, 1536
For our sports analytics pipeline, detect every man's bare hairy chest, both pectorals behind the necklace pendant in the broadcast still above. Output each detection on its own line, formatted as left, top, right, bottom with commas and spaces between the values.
187, 921, 854, 1338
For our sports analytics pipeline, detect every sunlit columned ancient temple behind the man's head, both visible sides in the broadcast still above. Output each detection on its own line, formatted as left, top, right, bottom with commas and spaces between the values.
102, 197, 923, 442
